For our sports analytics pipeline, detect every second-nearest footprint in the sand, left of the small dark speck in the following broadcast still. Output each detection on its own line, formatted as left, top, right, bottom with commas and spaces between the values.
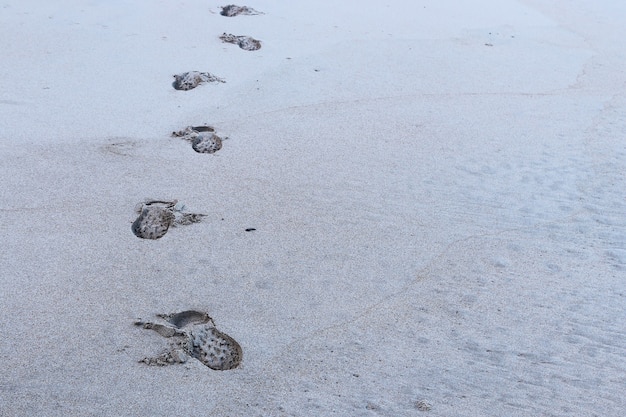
131, 200, 206, 239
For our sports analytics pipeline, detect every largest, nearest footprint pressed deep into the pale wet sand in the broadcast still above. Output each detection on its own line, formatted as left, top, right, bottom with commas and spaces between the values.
135, 310, 242, 371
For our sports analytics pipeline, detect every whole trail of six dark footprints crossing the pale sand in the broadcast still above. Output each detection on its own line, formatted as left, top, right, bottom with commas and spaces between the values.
131, 5, 263, 370
